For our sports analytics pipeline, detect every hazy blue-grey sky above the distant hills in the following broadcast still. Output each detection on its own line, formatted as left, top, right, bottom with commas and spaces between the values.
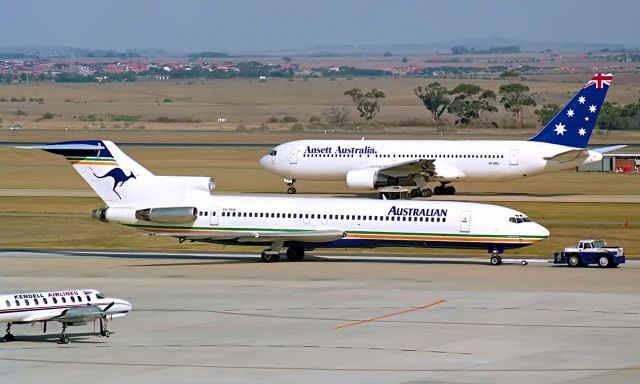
5, 0, 640, 52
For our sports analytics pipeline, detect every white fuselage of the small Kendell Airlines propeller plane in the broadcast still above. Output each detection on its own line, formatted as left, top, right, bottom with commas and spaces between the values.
0, 289, 131, 324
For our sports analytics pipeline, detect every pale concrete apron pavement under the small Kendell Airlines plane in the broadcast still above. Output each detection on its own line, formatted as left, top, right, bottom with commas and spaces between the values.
0, 251, 640, 383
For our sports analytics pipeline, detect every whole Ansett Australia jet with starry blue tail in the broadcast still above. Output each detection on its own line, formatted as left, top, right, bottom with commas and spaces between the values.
260, 74, 622, 197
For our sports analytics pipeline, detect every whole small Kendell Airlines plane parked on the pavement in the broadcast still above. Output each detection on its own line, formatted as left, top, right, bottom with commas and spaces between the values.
0, 289, 132, 344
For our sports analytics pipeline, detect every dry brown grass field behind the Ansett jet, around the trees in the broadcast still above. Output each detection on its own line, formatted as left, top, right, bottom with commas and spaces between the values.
0, 73, 640, 143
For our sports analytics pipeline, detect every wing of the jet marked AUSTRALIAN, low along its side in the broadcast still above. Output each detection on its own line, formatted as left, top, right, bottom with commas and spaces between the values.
146, 229, 346, 243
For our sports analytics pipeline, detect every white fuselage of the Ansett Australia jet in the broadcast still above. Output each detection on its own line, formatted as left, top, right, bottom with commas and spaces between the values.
260, 140, 602, 182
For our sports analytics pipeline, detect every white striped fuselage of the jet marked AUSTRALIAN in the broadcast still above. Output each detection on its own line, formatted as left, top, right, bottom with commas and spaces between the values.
105, 195, 549, 250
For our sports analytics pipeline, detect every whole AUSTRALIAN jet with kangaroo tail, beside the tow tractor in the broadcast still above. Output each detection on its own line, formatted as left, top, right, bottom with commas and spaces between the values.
22, 141, 549, 264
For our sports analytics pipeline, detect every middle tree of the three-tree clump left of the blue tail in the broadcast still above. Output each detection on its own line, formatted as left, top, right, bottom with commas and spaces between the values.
447, 83, 498, 125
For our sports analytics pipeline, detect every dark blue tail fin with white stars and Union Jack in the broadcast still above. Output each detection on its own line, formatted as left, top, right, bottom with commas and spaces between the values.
529, 73, 613, 148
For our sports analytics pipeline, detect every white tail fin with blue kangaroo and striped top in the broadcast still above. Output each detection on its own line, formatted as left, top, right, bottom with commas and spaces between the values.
21, 140, 155, 206
